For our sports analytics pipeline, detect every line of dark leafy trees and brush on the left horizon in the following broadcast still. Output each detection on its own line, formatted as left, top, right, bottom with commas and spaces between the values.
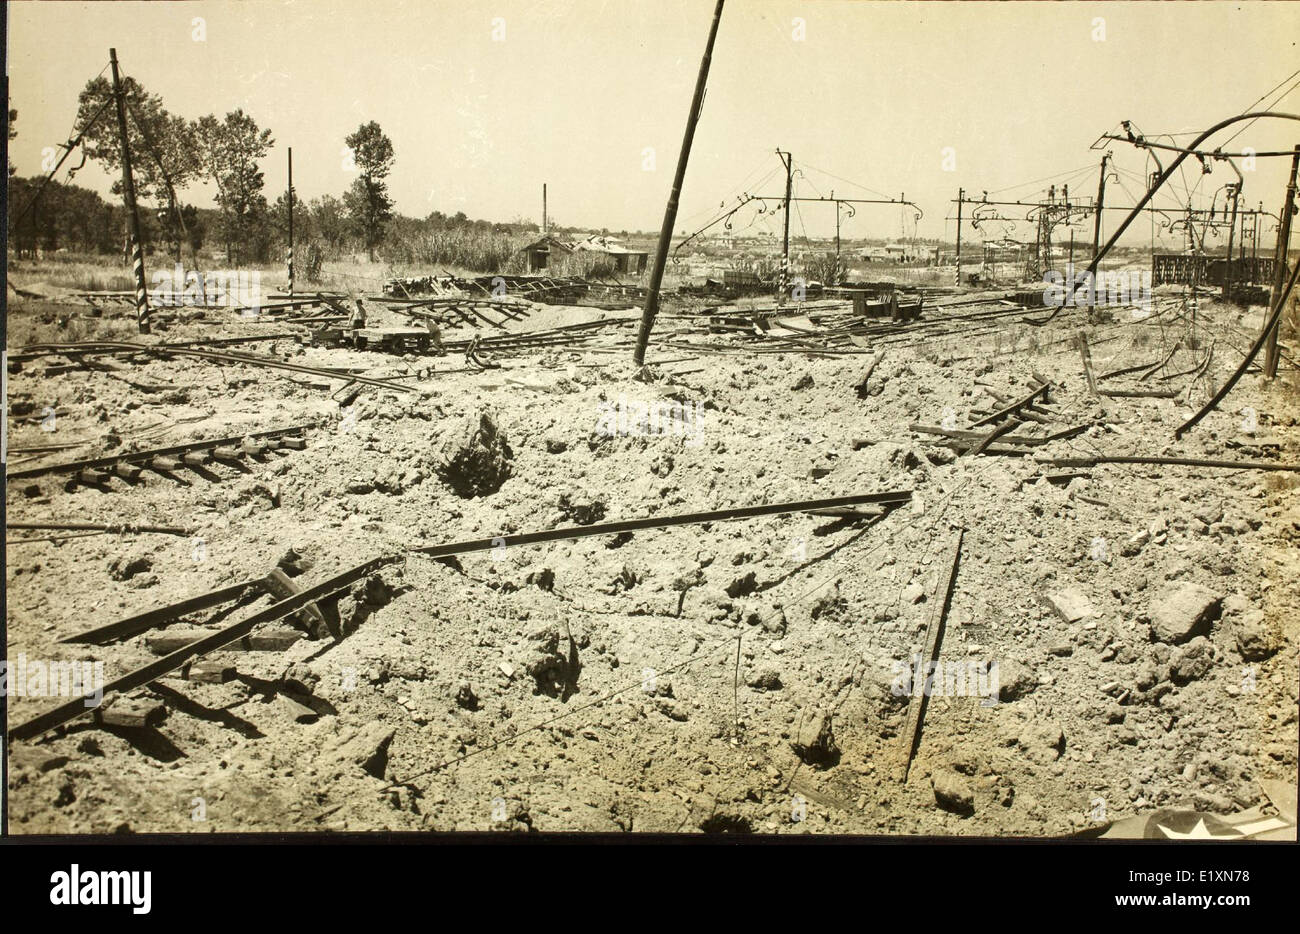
7, 77, 563, 269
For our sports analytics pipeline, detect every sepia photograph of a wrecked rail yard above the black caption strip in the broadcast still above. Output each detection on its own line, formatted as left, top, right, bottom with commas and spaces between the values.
0, 0, 1300, 874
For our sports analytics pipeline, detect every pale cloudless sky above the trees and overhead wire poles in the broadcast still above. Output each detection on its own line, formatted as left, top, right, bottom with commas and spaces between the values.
8, 0, 1300, 243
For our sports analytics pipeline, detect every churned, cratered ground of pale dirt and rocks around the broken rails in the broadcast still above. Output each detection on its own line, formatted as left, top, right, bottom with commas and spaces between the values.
7, 296, 1300, 836
